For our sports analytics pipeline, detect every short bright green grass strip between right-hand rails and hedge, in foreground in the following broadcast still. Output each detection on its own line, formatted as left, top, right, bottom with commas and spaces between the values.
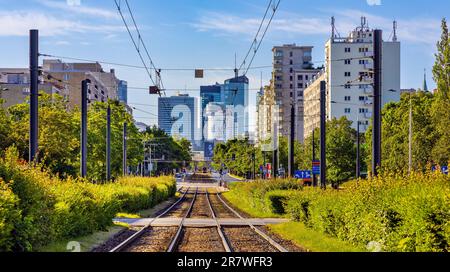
268, 222, 367, 252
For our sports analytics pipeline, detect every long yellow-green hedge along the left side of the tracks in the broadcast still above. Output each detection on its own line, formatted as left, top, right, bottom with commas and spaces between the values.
0, 149, 176, 251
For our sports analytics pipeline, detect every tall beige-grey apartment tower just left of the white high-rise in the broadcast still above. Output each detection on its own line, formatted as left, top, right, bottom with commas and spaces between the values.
272, 44, 319, 142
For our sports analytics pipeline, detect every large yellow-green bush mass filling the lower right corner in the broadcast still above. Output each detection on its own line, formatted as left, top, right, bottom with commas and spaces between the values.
286, 173, 450, 252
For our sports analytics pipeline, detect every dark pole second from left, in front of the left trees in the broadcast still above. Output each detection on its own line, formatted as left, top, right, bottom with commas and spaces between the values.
80, 79, 91, 178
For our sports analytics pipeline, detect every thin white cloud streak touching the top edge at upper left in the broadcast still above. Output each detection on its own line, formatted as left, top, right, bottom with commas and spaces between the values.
38, 0, 120, 19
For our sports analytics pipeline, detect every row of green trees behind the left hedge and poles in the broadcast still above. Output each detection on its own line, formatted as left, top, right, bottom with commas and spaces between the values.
0, 92, 190, 181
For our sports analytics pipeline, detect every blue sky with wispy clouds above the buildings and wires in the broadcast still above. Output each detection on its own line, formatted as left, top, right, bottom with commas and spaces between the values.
0, 0, 450, 130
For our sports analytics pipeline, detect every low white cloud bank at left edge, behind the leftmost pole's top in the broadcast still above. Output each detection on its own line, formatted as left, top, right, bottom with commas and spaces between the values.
0, 11, 123, 36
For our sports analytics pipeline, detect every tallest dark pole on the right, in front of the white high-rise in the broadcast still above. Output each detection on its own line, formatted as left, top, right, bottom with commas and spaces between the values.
372, 29, 383, 176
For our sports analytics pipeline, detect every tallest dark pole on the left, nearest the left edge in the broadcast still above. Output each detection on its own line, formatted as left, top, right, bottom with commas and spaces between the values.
29, 29, 39, 164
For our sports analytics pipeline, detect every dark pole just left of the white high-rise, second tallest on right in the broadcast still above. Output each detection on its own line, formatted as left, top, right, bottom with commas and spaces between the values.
320, 81, 327, 189
